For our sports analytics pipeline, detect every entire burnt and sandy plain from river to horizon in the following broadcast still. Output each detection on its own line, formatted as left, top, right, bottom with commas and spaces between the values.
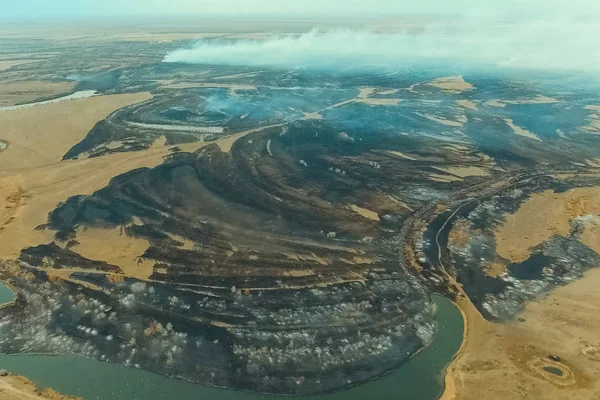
0, 19, 600, 400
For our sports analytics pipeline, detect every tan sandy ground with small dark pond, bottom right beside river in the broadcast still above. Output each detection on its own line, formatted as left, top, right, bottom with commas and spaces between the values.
442, 269, 600, 400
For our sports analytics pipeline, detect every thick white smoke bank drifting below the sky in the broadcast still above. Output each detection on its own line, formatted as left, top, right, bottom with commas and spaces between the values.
164, 16, 600, 74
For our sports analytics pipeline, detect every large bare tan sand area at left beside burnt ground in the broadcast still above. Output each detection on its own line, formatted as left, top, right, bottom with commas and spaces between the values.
0, 93, 168, 258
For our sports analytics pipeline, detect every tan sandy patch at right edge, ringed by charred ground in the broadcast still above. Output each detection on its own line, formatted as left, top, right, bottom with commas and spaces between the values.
495, 186, 600, 263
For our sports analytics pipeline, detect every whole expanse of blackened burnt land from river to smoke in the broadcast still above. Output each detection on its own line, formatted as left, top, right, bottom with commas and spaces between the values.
0, 37, 600, 395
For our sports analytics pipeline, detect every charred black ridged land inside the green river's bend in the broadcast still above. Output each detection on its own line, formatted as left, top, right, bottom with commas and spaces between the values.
6, 118, 500, 394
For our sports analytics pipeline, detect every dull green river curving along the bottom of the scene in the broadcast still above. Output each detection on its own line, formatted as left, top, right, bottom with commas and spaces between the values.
0, 284, 463, 400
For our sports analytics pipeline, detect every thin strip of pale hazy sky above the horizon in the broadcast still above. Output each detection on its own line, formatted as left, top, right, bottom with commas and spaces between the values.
0, 0, 600, 18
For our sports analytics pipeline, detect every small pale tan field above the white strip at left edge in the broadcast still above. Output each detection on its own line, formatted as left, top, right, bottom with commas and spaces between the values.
0, 81, 73, 107
